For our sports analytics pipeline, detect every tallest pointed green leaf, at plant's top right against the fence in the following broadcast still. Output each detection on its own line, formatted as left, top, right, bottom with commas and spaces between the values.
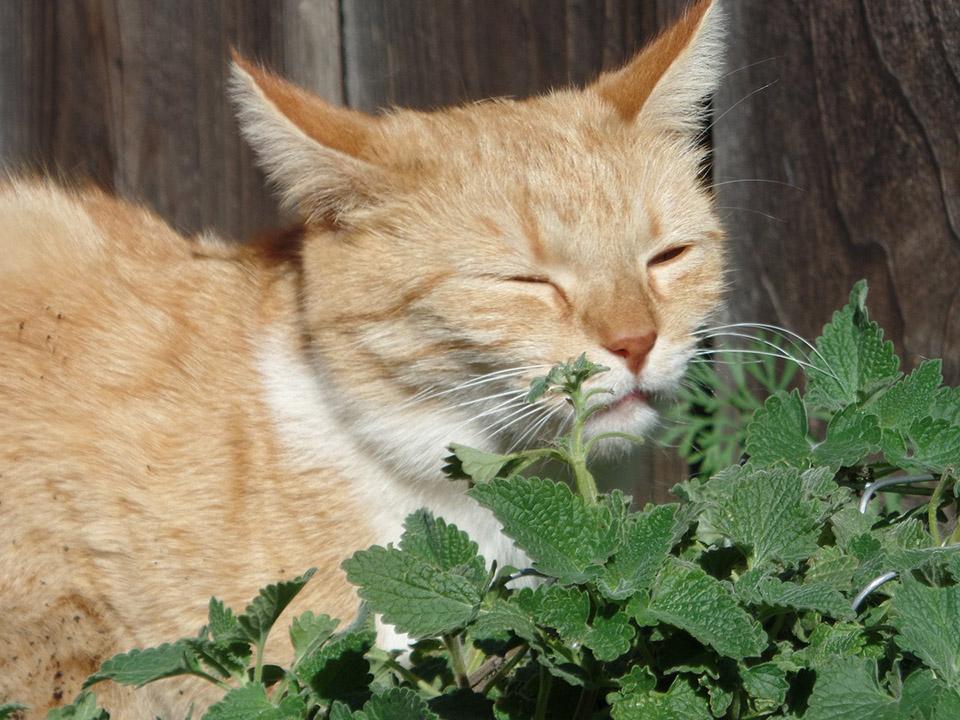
806, 280, 900, 410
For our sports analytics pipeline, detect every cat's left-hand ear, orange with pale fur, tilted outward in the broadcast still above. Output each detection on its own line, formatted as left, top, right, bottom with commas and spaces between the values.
230, 52, 388, 222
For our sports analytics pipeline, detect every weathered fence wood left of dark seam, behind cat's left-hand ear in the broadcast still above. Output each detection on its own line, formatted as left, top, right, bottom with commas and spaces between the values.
0, 0, 342, 242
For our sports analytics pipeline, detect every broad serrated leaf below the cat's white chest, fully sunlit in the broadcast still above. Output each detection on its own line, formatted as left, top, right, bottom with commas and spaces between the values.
343, 544, 488, 638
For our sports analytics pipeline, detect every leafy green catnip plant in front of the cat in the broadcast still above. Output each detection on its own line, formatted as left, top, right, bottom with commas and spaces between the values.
15, 282, 960, 720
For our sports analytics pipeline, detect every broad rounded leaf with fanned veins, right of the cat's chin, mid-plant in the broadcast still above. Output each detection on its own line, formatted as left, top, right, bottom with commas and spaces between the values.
708, 468, 820, 567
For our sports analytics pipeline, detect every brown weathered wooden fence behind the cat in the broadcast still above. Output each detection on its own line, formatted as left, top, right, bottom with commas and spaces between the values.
0, 0, 960, 499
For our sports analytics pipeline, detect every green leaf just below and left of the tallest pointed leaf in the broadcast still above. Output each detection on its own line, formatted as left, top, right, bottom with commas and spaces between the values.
747, 390, 810, 468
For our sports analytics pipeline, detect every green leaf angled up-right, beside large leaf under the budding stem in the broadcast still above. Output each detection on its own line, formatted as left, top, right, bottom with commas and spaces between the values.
597, 505, 689, 600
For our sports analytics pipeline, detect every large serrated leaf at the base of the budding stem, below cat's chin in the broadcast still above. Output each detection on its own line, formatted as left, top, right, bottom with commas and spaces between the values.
469, 477, 622, 584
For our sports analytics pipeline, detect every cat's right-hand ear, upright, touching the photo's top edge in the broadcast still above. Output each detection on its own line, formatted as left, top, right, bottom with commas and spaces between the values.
592, 0, 724, 133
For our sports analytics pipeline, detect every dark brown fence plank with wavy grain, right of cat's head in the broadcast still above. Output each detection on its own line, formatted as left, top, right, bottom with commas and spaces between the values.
713, 0, 960, 383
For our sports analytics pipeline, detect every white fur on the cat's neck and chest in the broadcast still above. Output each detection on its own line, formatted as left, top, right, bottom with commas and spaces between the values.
258, 333, 527, 649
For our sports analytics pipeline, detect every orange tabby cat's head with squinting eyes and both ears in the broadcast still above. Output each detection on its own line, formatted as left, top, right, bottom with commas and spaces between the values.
233, 0, 723, 476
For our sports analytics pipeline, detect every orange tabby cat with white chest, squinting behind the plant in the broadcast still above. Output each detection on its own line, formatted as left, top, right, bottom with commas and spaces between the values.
0, 0, 723, 718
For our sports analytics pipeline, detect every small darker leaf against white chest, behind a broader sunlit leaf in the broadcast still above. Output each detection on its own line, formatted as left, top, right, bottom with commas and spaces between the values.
400, 509, 487, 588
